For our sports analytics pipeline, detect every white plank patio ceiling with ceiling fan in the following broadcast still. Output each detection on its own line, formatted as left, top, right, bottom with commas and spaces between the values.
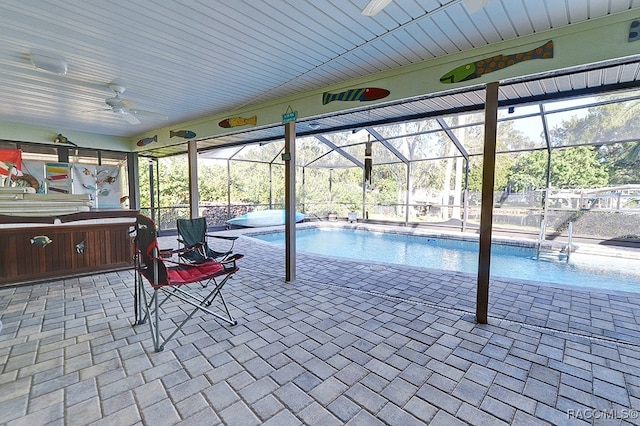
0, 0, 640, 141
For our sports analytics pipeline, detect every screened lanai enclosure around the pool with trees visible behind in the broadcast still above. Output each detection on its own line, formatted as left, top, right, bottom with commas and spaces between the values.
139, 85, 640, 245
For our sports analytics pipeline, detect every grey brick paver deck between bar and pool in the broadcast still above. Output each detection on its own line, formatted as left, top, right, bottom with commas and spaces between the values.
0, 230, 640, 426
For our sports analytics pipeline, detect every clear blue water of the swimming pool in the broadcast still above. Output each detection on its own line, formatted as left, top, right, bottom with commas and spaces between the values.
253, 228, 640, 292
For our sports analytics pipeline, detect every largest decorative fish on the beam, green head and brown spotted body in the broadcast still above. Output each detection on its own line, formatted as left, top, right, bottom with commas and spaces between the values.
440, 40, 553, 84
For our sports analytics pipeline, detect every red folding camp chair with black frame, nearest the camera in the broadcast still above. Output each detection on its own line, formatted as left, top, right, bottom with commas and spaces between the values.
134, 215, 243, 352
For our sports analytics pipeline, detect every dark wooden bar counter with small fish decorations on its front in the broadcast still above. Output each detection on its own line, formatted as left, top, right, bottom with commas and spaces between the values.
0, 209, 138, 287
